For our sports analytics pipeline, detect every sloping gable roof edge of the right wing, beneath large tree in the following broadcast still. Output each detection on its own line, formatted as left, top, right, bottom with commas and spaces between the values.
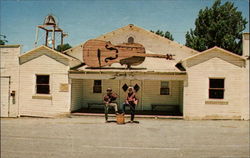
179, 46, 246, 67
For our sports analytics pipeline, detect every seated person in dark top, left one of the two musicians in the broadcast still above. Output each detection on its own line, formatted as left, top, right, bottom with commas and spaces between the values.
103, 88, 118, 122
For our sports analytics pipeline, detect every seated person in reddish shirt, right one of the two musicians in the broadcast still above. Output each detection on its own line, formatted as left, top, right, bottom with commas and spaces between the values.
122, 87, 138, 122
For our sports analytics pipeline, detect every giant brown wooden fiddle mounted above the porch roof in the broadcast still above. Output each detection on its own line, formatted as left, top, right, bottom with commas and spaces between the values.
83, 39, 174, 67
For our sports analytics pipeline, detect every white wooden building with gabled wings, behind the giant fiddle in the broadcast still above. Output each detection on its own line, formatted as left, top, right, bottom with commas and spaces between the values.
1, 25, 249, 120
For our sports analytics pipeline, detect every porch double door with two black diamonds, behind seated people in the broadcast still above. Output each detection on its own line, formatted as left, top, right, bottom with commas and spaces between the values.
119, 80, 142, 110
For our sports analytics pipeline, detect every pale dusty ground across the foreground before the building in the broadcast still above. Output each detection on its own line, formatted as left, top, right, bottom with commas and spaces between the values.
1, 116, 250, 158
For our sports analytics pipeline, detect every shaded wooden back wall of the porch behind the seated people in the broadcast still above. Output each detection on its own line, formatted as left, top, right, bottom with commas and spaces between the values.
72, 79, 183, 110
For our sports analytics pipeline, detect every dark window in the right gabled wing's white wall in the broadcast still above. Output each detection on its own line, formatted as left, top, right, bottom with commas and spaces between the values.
209, 78, 224, 99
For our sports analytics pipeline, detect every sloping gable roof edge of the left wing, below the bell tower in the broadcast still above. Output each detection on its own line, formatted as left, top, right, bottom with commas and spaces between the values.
19, 45, 81, 67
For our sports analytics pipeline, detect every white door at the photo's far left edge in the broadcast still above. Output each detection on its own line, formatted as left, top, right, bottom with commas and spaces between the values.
0, 77, 10, 117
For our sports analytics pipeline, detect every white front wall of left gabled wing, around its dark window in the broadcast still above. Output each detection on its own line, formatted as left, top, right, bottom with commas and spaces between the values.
20, 55, 70, 116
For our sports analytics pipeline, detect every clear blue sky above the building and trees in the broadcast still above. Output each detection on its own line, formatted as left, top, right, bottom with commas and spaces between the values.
0, 0, 249, 52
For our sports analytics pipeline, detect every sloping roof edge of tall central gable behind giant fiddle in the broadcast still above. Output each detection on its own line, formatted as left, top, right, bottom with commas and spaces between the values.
63, 24, 199, 53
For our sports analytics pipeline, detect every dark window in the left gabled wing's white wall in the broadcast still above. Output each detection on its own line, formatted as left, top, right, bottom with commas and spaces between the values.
36, 75, 50, 94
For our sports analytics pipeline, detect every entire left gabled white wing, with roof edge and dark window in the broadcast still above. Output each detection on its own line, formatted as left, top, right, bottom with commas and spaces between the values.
19, 46, 81, 117
